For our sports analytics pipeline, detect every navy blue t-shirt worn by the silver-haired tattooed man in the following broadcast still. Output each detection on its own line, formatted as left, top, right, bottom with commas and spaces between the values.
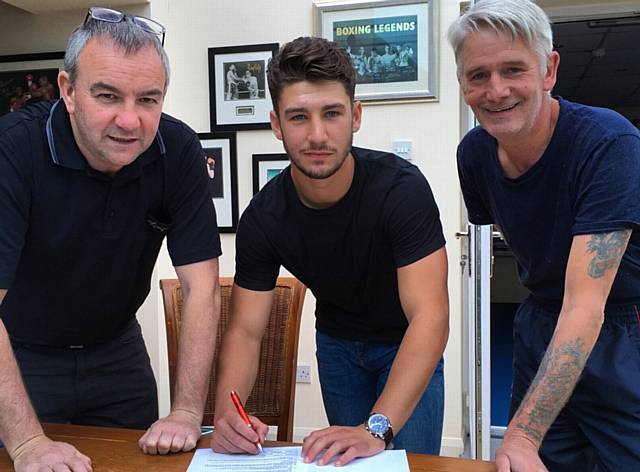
458, 98, 640, 303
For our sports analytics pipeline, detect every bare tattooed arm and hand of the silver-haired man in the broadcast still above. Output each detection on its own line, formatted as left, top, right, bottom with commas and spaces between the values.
496, 230, 631, 472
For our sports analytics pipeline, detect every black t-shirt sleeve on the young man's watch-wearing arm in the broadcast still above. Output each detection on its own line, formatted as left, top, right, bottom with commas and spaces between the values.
386, 168, 445, 267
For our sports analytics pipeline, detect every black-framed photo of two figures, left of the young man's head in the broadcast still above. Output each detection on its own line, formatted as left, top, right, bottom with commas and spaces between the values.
209, 43, 278, 131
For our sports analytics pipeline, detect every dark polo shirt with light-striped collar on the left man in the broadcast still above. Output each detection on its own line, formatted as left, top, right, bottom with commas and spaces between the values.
0, 101, 221, 346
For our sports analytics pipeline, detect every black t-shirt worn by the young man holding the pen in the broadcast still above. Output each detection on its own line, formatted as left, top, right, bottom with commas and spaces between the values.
235, 148, 445, 343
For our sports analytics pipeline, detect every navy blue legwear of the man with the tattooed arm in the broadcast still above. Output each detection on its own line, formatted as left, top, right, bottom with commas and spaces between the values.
509, 298, 640, 472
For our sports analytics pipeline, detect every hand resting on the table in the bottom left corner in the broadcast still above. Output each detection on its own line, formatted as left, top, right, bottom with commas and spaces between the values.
11, 434, 93, 472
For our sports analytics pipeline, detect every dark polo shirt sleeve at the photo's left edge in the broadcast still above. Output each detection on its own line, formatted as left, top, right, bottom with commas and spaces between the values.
0, 123, 32, 289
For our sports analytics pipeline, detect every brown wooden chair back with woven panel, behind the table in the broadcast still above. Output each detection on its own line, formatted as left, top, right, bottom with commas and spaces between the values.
160, 277, 306, 441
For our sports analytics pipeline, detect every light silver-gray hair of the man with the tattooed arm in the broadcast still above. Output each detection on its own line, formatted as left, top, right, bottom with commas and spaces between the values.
448, 0, 553, 79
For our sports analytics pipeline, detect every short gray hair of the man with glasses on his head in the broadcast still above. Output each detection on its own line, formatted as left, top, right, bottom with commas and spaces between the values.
64, 17, 170, 90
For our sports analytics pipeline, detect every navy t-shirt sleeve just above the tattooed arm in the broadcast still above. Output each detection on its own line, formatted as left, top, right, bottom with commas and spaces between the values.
572, 134, 640, 235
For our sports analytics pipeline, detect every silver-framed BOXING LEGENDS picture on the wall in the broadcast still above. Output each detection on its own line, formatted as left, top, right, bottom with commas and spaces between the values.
314, 0, 438, 100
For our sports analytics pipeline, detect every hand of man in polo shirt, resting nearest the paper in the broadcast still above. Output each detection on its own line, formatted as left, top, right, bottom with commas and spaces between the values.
138, 410, 201, 454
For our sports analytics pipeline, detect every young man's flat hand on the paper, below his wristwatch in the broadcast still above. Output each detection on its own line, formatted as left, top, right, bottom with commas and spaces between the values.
302, 425, 384, 466
